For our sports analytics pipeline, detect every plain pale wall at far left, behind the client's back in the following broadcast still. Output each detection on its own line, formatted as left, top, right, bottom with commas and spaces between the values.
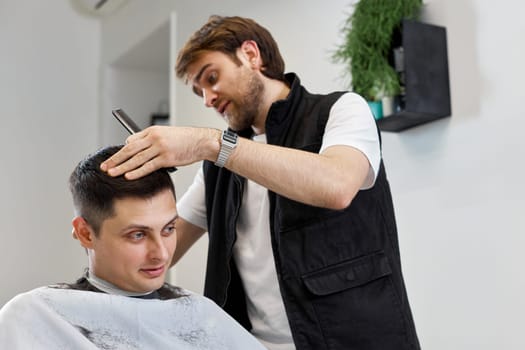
0, 0, 100, 305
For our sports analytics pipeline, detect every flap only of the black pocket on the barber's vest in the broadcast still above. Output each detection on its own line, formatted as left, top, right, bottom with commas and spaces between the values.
302, 251, 392, 296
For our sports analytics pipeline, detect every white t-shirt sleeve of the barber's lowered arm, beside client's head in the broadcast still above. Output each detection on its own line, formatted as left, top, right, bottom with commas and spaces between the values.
177, 167, 208, 230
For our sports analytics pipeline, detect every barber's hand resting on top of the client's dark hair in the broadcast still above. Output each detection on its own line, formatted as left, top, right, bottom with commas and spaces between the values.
100, 126, 221, 180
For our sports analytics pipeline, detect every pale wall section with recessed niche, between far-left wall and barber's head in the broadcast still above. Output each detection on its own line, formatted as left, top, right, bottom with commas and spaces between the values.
100, 1, 172, 144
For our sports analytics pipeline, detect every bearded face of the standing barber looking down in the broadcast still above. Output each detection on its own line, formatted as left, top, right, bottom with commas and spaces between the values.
188, 50, 264, 131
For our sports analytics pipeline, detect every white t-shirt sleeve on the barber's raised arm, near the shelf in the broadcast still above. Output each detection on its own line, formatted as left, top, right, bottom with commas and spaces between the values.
320, 92, 381, 190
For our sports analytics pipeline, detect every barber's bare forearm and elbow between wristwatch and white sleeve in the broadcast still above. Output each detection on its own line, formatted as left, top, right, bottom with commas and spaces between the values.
226, 139, 370, 209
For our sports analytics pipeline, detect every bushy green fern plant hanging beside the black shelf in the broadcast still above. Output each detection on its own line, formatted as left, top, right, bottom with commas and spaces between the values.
332, 0, 422, 101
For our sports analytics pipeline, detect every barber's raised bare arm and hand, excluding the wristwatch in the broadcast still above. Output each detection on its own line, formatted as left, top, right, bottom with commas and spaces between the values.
102, 126, 370, 209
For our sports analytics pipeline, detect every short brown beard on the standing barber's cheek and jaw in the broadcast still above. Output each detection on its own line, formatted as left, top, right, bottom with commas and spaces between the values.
228, 72, 264, 131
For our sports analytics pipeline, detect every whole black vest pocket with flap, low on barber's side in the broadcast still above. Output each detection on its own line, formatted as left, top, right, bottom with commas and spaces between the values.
302, 251, 413, 350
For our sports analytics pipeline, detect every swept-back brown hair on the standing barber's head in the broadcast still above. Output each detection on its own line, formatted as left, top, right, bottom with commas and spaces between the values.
175, 16, 284, 81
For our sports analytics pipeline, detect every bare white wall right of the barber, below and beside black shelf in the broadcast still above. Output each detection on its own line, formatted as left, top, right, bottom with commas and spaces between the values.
383, 0, 525, 350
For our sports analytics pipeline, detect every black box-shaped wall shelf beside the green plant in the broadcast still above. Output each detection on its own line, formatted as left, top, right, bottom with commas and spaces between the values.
377, 20, 451, 132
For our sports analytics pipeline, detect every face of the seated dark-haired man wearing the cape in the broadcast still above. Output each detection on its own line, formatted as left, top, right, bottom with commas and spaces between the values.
91, 190, 177, 292
